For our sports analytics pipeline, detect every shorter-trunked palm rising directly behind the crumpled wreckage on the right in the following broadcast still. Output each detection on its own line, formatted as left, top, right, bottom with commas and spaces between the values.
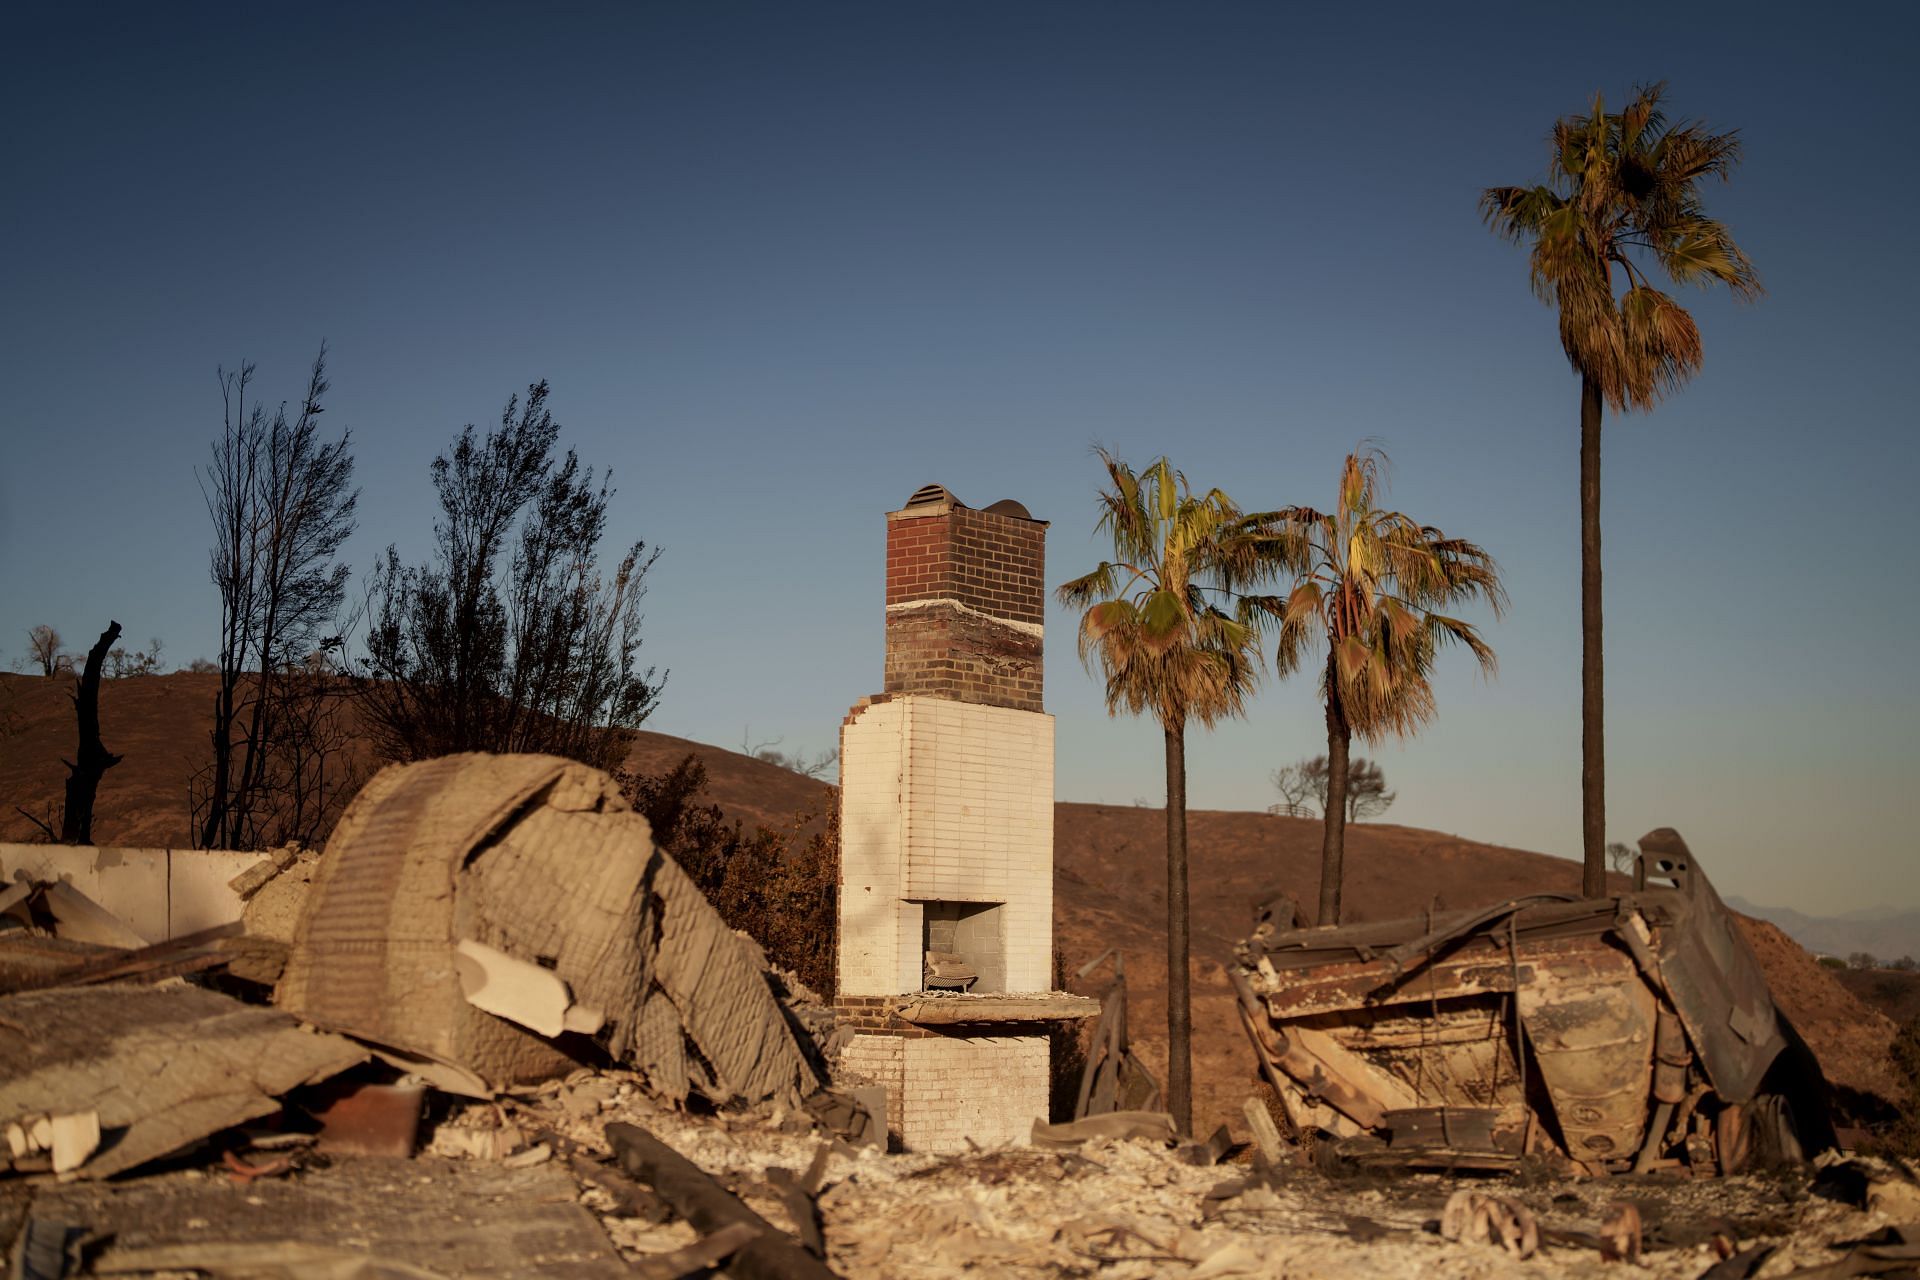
1244, 449, 1507, 925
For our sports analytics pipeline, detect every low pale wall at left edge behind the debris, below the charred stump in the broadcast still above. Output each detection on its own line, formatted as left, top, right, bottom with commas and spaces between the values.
0, 844, 265, 942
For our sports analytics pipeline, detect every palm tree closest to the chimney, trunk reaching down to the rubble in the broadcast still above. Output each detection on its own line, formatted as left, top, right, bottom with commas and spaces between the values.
1060, 449, 1260, 1132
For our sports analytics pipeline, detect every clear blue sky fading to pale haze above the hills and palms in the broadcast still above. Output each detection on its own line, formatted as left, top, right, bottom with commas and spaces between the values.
0, 2, 1920, 912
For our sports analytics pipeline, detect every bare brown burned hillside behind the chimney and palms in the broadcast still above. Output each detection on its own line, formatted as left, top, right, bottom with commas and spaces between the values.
0, 674, 1893, 1125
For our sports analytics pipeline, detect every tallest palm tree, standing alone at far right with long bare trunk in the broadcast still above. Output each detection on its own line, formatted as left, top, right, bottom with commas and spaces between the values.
1480, 84, 1761, 898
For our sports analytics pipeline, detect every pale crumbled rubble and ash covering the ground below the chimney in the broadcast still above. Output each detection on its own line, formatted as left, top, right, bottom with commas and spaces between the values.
382, 1073, 1905, 1280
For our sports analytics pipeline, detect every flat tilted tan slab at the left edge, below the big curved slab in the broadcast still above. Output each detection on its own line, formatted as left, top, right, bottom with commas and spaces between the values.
0, 986, 367, 1178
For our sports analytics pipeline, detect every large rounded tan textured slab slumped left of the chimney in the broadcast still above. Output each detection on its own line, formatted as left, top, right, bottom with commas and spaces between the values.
276, 754, 820, 1105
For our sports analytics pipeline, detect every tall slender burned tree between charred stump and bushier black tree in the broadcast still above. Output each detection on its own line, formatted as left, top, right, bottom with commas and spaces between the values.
192, 345, 359, 848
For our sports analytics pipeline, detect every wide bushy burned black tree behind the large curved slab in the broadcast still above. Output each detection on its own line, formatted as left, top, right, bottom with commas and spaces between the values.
355, 382, 664, 764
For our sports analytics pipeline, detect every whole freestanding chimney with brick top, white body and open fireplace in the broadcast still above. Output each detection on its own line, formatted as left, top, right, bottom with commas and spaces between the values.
839, 486, 1096, 1151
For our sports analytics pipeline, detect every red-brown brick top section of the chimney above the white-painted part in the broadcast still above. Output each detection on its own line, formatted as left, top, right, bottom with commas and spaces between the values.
881, 484, 1046, 712
